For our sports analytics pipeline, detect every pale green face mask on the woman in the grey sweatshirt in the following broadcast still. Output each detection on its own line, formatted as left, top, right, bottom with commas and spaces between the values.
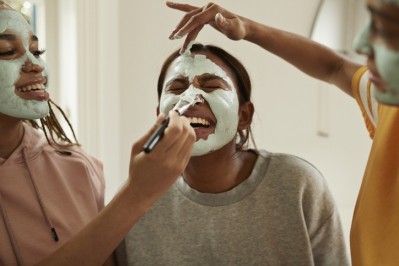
159, 54, 239, 156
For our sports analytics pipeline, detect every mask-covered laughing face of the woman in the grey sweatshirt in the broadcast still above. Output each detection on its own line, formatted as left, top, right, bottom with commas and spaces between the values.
159, 53, 239, 156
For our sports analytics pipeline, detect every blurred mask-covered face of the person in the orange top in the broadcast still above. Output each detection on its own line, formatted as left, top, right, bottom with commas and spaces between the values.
354, 0, 399, 105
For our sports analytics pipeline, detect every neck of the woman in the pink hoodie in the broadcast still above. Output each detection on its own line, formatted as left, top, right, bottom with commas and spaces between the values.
0, 114, 24, 159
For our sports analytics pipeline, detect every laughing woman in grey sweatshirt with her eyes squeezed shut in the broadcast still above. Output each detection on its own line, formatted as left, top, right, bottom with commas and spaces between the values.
117, 43, 350, 266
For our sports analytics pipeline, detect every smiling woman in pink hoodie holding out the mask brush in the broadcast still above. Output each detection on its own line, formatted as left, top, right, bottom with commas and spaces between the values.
0, 1, 195, 266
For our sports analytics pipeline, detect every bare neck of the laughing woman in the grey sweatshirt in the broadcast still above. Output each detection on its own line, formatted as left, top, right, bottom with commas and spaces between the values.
183, 142, 256, 193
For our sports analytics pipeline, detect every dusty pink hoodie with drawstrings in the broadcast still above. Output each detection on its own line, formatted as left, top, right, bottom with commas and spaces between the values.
0, 125, 105, 266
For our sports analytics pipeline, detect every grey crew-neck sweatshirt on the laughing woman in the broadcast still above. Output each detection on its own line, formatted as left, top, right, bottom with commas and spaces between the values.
117, 151, 350, 266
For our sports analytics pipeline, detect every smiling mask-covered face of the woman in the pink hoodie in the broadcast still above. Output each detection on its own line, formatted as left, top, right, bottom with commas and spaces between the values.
0, 9, 49, 119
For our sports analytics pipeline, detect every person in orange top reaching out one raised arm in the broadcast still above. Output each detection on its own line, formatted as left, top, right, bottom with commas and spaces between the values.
167, 0, 399, 266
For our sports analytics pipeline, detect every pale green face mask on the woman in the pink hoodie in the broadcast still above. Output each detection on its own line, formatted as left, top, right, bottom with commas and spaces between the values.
0, 10, 49, 119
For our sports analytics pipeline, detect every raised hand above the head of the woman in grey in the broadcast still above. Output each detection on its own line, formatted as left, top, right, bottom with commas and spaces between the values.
166, 1, 247, 53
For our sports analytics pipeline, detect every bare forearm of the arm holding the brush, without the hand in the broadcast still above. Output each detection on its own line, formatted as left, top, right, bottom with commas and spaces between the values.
36, 182, 151, 266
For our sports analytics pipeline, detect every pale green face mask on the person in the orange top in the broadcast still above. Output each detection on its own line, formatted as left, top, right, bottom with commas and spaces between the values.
354, 14, 399, 105
